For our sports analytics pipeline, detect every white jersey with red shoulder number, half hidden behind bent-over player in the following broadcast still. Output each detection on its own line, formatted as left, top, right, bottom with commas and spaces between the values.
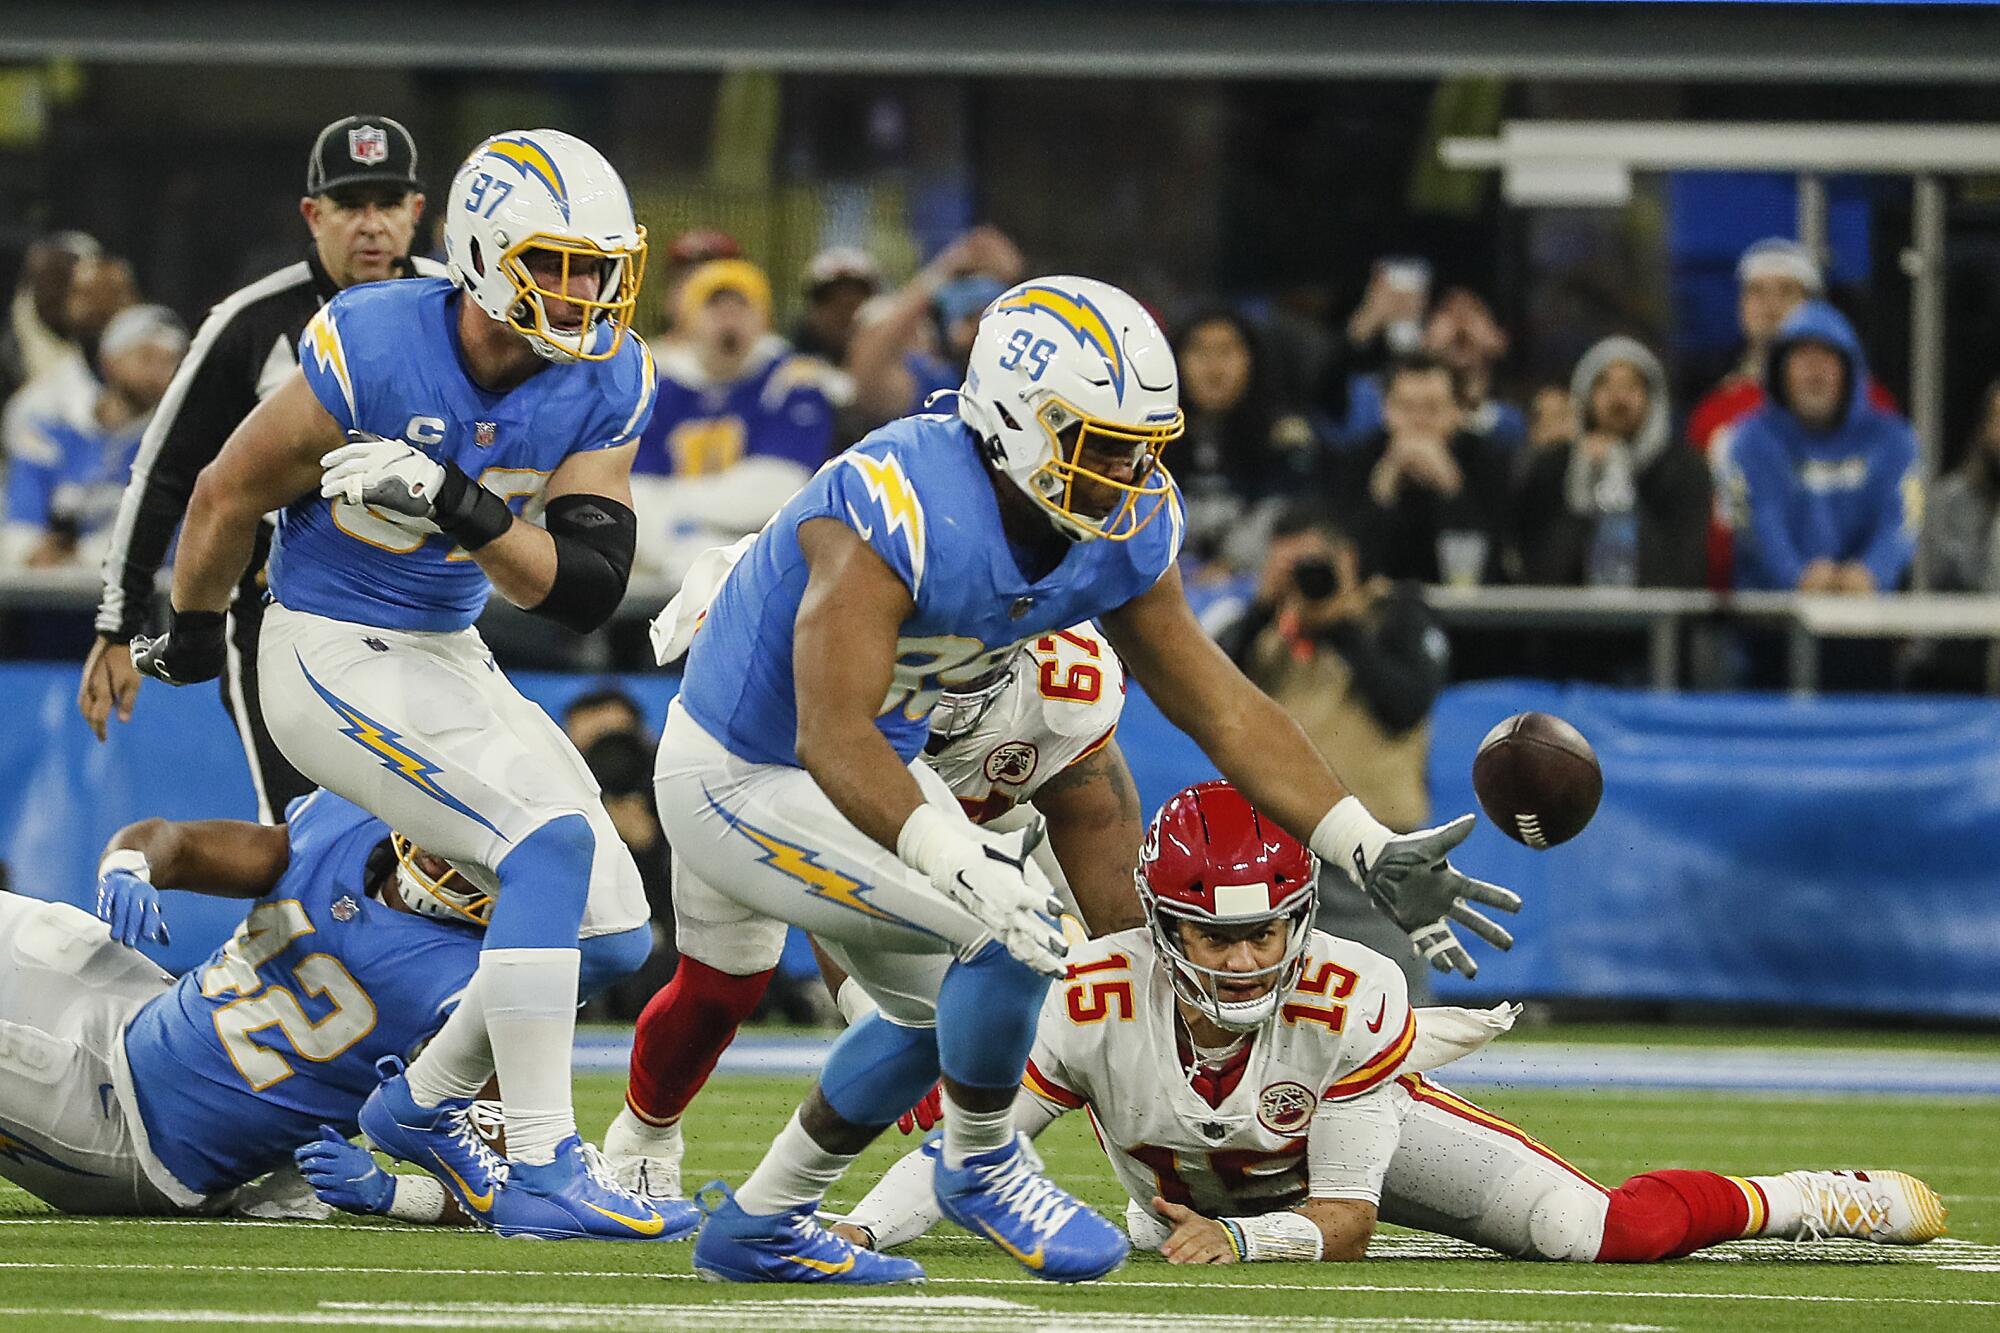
924, 620, 1124, 825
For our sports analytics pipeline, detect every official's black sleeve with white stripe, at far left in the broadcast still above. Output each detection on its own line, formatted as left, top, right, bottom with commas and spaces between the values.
96, 314, 268, 642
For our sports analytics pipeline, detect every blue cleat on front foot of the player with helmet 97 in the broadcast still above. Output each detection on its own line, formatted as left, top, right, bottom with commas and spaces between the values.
488, 1135, 702, 1241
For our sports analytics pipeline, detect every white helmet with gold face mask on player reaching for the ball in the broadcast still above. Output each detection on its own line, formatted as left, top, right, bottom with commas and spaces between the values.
958, 276, 1186, 540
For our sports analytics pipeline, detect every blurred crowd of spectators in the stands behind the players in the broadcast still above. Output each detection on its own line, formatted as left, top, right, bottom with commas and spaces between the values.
0, 226, 1968, 675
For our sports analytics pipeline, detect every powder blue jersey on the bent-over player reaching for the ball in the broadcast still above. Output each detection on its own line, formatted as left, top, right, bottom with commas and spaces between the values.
680, 414, 1182, 765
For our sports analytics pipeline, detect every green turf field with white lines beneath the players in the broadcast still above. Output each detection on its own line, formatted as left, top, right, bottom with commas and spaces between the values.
0, 1033, 2000, 1333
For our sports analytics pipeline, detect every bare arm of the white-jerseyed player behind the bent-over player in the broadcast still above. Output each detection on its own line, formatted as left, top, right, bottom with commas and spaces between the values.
1032, 741, 1146, 935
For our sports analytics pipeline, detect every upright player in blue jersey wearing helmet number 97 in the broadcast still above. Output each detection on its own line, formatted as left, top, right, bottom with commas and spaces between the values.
132, 130, 694, 1239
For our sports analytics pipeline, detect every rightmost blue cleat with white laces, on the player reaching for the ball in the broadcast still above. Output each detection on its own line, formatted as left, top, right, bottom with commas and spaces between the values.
932, 1135, 1132, 1283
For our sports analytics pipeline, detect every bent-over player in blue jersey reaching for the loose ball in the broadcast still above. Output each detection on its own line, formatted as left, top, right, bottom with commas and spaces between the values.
638, 276, 1518, 1283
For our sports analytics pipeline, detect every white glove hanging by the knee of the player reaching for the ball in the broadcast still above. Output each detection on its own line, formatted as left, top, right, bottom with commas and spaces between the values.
896, 805, 1070, 977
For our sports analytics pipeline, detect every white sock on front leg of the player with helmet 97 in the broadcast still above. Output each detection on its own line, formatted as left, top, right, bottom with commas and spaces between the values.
478, 949, 582, 1167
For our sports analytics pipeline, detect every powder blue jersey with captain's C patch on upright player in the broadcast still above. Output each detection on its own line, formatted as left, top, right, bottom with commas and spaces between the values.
270, 278, 656, 630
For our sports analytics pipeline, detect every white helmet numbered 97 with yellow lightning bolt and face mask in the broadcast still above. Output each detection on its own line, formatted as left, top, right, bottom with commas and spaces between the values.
444, 130, 646, 362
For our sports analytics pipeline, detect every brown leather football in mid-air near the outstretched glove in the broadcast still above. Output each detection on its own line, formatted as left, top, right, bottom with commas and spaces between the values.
1472, 713, 1604, 851
